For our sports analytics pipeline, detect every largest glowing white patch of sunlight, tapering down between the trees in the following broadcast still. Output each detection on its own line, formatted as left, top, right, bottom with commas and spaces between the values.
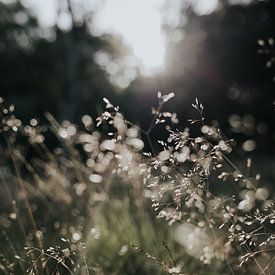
94, 0, 165, 73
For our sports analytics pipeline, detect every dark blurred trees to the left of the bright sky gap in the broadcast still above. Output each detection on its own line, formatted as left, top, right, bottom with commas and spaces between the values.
0, 1, 125, 120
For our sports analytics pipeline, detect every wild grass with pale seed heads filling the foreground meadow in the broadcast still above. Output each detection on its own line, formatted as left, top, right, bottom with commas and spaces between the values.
0, 93, 275, 274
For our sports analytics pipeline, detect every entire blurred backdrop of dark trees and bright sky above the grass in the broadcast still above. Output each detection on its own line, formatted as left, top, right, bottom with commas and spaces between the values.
0, 0, 275, 153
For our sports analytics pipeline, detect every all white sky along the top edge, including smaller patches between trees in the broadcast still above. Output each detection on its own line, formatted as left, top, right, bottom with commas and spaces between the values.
22, 0, 223, 76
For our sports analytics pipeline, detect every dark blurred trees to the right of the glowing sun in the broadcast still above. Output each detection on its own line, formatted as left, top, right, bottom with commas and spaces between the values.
128, 1, 275, 127
